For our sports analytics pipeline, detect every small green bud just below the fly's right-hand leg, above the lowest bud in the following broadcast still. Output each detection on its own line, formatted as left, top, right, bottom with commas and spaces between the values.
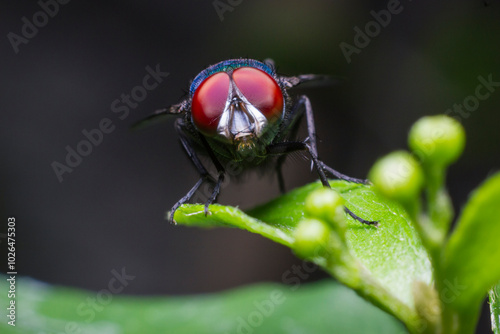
305, 188, 345, 224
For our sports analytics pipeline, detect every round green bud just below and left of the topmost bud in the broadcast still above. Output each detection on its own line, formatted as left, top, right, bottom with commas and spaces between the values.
368, 151, 424, 202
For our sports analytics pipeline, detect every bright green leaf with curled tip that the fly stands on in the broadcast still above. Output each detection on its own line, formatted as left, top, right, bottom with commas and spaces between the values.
175, 181, 432, 324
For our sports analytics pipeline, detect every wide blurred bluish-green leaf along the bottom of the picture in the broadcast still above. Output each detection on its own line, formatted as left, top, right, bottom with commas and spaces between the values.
0, 275, 406, 334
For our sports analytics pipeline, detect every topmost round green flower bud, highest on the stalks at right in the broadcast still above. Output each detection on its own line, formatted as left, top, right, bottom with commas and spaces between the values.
408, 115, 465, 167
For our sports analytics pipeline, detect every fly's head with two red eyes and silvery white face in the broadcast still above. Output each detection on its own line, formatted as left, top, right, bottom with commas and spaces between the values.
190, 59, 286, 157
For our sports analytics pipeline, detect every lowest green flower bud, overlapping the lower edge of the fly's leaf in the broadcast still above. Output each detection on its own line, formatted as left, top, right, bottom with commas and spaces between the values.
294, 218, 330, 258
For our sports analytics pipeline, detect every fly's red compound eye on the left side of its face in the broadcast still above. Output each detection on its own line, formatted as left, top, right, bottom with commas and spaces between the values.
191, 72, 229, 136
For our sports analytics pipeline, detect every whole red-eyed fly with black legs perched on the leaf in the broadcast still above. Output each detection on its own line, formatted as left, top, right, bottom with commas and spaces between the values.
134, 59, 378, 225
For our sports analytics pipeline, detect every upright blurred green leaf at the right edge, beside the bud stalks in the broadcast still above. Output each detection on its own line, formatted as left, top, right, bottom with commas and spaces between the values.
441, 173, 500, 310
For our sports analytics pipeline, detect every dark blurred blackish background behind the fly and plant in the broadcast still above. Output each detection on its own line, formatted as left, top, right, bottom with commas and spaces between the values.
0, 0, 500, 332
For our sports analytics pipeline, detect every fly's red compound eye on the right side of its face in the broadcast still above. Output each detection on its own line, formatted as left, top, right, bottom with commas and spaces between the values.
233, 67, 283, 121
